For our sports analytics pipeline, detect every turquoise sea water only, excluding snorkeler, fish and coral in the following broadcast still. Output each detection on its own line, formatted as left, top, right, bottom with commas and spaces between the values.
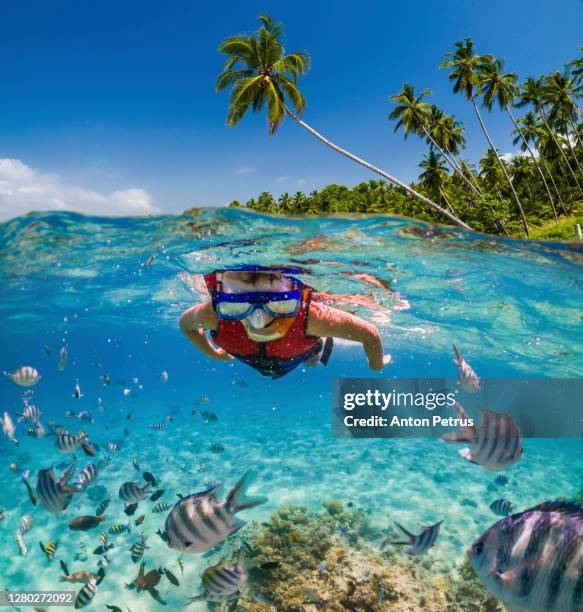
0, 209, 583, 611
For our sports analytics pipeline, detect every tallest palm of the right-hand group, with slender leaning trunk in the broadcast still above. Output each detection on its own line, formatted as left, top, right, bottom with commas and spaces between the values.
440, 38, 530, 236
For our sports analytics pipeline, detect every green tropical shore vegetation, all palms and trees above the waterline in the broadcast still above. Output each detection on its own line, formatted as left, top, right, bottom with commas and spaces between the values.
216, 15, 583, 238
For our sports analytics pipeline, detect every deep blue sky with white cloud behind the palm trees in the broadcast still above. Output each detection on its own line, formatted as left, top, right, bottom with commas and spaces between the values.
0, 0, 583, 218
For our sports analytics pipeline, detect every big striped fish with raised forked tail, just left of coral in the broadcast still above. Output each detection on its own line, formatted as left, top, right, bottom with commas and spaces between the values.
164, 472, 267, 553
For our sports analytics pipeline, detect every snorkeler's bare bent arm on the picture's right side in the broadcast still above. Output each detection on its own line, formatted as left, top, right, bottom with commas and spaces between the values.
306, 302, 391, 370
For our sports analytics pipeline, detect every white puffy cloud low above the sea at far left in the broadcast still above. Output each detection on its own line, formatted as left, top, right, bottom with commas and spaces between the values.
0, 159, 160, 220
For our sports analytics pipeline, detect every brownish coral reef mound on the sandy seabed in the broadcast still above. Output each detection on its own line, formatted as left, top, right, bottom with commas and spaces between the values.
213, 500, 504, 612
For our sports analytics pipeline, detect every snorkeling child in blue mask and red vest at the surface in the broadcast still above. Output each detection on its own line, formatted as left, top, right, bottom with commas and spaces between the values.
180, 266, 391, 378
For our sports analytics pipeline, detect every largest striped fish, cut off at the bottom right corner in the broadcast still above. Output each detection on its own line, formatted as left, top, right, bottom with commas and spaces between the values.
468, 501, 583, 612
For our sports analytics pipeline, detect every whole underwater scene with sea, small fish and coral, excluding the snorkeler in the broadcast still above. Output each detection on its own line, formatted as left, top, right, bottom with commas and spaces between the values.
0, 209, 583, 612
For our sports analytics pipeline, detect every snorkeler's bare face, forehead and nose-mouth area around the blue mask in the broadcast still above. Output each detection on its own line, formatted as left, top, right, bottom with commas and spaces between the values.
221, 272, 293, 342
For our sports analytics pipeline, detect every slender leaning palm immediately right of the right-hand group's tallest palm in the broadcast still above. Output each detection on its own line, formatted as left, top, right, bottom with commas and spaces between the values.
479, 57, 557, 224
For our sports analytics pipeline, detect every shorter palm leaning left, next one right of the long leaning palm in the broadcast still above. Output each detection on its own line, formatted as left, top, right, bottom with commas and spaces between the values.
389, 83, 480, 195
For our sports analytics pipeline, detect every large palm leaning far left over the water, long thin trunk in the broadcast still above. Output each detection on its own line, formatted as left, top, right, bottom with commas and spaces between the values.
216, 15, 471, 229
